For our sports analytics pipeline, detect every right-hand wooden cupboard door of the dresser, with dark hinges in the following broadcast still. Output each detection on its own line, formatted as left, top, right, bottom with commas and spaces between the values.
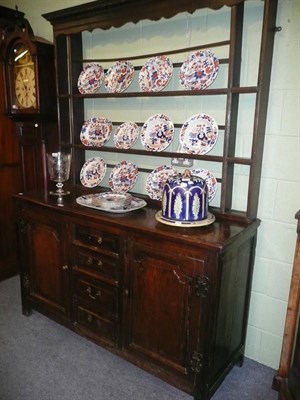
125, 239, 208, 384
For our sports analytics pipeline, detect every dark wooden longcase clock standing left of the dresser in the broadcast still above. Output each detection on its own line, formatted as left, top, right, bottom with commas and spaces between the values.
1, 10, 58, 191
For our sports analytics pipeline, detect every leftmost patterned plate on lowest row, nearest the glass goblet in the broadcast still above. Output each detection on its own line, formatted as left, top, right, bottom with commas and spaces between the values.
80, 157, 106, 188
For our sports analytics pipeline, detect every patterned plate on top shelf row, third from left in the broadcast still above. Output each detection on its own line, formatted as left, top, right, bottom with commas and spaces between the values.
139, 56, 173, 92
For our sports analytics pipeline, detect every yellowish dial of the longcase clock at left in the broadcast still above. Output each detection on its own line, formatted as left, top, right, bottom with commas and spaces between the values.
15, 65, 36, 108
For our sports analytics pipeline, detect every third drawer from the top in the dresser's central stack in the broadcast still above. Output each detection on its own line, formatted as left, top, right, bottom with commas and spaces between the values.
73, 277, 118, 317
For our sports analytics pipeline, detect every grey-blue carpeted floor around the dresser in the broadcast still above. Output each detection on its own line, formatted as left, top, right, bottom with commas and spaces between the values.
0, 277, 278, 400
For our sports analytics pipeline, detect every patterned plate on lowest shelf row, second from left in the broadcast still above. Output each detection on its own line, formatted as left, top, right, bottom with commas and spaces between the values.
109, 161, 138, 193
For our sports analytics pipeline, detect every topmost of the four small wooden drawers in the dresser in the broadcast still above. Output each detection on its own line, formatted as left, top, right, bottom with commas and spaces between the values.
74, 225, 120, 255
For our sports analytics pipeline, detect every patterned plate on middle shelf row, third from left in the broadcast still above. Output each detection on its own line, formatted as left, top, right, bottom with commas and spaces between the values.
141, 114, 174, 151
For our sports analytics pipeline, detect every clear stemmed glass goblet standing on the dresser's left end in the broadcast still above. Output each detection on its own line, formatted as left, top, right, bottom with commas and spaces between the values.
47, 152, 71, 197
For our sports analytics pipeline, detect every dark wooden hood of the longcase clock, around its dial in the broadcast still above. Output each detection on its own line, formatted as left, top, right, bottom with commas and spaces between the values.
1, 11, 57, 121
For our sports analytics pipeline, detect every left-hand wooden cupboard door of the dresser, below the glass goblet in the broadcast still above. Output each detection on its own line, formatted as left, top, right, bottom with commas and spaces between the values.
22, 211, 69, 317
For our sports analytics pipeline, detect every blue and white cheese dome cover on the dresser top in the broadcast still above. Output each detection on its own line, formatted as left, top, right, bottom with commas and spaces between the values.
162, 170, 208, 221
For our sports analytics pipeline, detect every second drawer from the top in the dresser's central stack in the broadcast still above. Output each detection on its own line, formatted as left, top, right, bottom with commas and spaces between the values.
73, 247, 119, 284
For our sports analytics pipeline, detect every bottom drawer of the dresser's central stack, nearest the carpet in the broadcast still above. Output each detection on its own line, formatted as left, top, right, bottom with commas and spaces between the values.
74, 304, 119, 343
